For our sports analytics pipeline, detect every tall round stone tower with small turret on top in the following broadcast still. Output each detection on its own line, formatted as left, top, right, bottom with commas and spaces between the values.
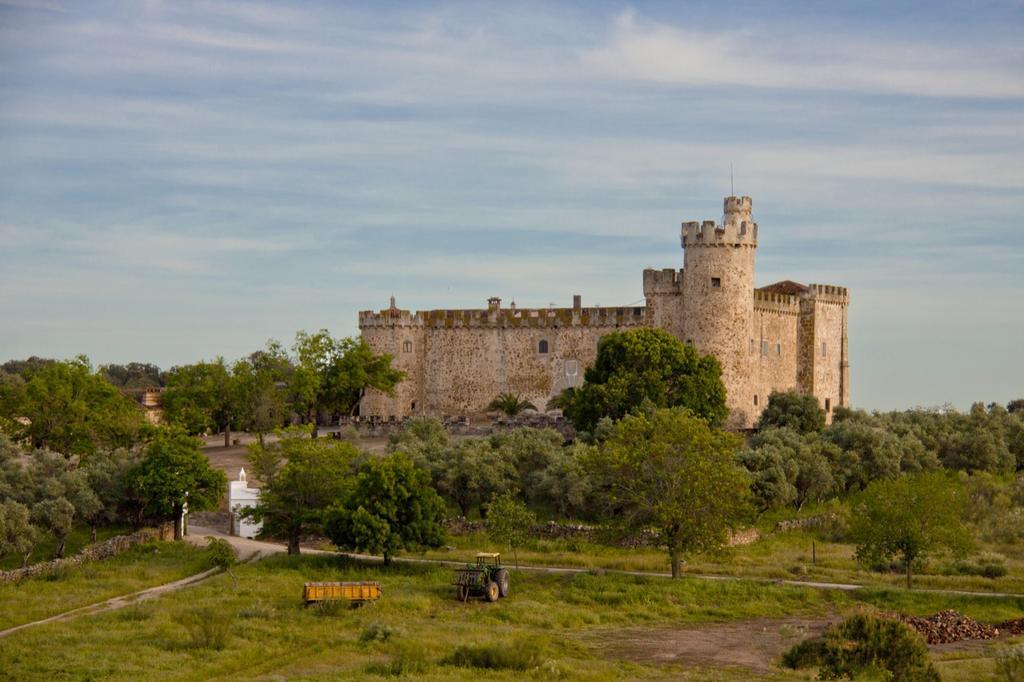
682, 197, 764, 425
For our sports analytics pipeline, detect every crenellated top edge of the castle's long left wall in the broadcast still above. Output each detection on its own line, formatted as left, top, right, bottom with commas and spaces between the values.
359, 306, 645, 330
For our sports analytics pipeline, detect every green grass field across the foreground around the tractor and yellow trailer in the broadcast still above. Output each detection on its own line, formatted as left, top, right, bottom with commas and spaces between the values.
0, 545, 1024, 680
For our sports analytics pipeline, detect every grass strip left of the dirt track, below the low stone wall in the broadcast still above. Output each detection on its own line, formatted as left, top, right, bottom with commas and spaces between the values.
0, 543, 206, 630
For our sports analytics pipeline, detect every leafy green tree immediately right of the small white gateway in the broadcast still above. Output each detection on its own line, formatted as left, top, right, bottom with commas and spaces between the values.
243, 438, 359, 554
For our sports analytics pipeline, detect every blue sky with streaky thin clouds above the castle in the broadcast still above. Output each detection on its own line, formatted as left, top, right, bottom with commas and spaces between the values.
0, 0, 1024, 410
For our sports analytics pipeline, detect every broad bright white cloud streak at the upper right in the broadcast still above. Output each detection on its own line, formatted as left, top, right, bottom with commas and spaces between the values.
583, 10, 1024, 98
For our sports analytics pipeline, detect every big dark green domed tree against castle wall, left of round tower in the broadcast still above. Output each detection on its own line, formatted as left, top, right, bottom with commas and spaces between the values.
565, 329, 729, 431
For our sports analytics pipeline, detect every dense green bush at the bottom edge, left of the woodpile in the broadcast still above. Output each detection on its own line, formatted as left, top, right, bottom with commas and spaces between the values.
782, 614, 939, 682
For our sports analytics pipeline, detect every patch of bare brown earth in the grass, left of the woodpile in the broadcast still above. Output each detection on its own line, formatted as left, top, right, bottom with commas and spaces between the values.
590, 617, 839, 672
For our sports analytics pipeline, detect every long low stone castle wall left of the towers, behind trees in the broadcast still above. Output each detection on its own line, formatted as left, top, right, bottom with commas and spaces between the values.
359, 306, 646, 418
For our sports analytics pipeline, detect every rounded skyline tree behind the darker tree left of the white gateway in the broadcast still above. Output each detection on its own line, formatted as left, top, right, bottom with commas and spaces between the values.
160, 357, 241, 447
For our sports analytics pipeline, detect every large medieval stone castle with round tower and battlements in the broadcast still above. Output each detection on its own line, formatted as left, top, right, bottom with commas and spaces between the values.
359, 197, 850, 426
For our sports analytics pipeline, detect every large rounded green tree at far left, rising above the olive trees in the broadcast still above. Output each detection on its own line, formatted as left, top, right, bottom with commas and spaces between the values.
0, 356, 144, 457
